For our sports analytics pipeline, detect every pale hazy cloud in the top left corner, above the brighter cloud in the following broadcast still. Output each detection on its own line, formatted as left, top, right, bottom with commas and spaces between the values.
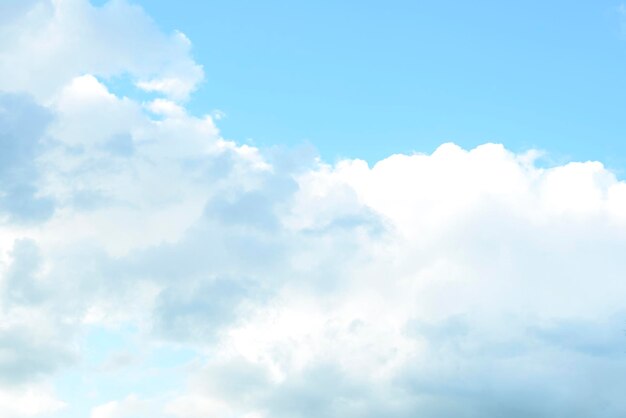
0, 0, 203, 100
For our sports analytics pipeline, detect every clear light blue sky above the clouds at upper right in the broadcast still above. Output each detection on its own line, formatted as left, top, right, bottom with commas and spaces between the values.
133, 0, 626, 169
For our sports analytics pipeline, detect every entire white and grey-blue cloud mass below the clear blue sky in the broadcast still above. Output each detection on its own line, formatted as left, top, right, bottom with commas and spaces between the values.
0, 0, 626, 418
